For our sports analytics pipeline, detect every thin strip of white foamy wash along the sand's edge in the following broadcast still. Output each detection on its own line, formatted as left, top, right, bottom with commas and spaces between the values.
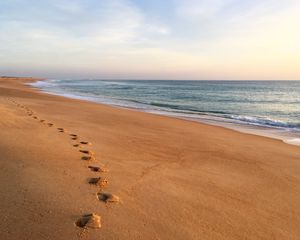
27, 79, 300, 146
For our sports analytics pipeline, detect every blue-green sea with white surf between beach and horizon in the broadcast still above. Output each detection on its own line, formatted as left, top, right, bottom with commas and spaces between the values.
32, 79, 300, 145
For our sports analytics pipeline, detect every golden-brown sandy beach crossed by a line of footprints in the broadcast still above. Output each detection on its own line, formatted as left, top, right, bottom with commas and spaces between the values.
0, 78, 300, 240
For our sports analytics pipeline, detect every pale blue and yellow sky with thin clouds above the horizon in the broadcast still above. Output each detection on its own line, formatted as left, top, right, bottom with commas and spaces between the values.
0, 0, 300, 80
